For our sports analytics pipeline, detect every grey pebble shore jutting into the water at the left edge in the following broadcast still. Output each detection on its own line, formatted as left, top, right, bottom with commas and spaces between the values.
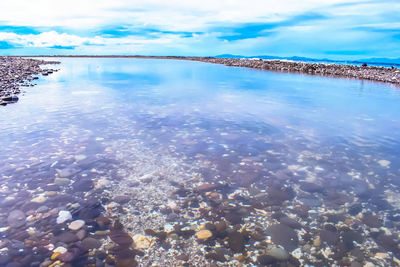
0, 57, 59, 106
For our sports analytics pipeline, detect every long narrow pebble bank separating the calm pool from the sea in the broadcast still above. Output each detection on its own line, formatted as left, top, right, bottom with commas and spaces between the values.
23, 55, 400, 85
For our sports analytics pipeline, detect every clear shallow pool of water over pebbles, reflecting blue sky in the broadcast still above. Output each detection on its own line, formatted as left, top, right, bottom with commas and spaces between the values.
0, 58, 400, 266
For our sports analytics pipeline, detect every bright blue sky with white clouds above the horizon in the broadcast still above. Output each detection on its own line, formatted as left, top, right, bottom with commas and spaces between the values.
0, 0, 400, 59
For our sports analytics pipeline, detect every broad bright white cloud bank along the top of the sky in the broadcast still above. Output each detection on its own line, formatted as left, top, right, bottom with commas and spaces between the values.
0, 0, 368, 31
